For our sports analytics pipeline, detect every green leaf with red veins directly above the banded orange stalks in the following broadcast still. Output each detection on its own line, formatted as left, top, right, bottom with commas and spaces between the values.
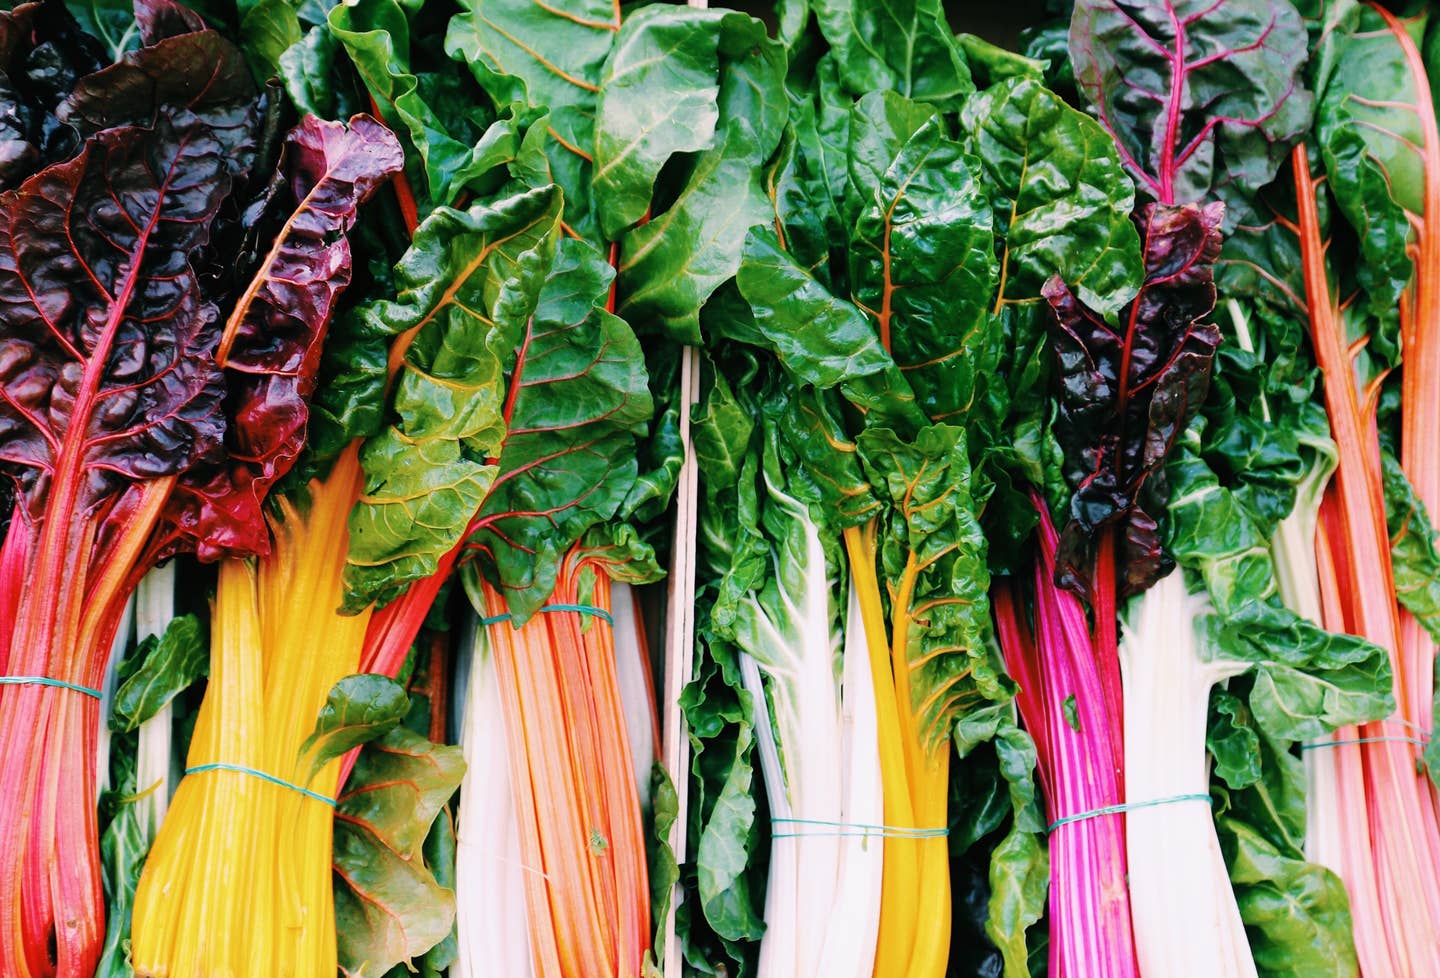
471, 239, 652, 621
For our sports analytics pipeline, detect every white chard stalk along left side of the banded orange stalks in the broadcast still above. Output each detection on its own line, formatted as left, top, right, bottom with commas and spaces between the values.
454, 614, 534, 978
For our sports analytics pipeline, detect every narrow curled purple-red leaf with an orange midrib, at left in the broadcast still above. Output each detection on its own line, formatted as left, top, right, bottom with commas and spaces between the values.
159, 115, 405, 560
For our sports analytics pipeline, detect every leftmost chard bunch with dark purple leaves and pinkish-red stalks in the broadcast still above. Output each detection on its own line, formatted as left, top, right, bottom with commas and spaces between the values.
0, 0, 393, 977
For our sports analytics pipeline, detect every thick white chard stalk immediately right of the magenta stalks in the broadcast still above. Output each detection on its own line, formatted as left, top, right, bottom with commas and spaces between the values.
1120, 572, 1256, 978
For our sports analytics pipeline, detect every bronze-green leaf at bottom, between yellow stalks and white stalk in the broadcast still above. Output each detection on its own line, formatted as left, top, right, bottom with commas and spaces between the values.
334, 727, 465, 978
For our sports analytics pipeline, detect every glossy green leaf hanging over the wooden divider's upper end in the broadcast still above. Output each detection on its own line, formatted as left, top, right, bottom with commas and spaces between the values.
610, 7, 789, 343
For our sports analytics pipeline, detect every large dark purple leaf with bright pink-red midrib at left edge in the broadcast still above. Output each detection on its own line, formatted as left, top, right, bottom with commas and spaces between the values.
0, 112, 249, 517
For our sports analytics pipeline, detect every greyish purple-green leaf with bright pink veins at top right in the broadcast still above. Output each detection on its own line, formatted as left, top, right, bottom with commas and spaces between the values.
1070, 0, 1313, 205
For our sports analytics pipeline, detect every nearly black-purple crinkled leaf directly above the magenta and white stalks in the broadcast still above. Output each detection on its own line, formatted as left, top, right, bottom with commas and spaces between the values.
1044, 203, 1224, 595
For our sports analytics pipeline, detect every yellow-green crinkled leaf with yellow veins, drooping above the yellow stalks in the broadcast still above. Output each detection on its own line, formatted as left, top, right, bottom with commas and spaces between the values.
346, 187, 560, 606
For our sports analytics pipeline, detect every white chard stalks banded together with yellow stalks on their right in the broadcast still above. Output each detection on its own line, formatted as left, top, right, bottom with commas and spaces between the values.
737, 485, 884, 978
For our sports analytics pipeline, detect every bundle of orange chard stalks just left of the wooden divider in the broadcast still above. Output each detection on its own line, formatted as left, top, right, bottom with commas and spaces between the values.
482, 555, 651, 978
